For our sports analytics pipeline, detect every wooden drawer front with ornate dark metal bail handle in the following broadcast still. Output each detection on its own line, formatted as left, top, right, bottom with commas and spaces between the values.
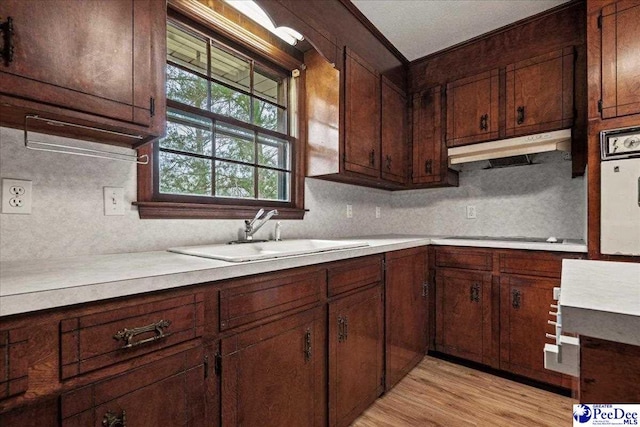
60, 293, 204, 379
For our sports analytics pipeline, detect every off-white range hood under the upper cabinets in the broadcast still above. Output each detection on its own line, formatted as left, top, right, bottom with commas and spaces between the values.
448, 129, 571, 165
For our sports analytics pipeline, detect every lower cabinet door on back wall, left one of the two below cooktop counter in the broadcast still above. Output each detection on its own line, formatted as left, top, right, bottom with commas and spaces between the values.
436, 268, 492, 364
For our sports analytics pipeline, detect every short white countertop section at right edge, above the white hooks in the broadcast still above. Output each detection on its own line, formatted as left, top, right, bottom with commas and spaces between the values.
560, 259, 640, 346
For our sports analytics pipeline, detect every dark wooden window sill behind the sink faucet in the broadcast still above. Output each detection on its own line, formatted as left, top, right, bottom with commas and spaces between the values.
133, 202, 306, 219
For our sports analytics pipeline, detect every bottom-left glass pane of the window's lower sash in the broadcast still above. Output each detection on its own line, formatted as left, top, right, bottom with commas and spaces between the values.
160, 151, 211, 196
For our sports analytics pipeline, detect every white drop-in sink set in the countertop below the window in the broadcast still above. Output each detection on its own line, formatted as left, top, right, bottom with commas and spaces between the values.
168, 239, 369, 262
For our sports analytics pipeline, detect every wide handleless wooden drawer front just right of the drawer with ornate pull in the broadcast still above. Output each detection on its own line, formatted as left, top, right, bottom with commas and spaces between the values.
220, 270, 325, 331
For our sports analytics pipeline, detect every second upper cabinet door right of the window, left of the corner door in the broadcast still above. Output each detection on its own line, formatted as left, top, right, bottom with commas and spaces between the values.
381, 77, 407, 184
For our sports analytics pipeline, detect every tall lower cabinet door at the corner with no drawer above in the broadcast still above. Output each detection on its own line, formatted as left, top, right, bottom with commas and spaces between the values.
385, 248, 428, 390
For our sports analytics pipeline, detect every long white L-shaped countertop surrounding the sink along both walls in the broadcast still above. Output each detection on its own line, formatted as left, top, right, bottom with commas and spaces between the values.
0, 235, 586, 317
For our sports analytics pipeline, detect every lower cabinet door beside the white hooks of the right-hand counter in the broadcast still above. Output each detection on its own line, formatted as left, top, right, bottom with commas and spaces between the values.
500, 275, 562, 386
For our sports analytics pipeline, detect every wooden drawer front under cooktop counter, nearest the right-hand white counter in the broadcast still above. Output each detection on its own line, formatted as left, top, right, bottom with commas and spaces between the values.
500, 252, 582, 279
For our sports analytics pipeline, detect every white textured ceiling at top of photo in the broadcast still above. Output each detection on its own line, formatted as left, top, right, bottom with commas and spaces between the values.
351, 0, 568, 61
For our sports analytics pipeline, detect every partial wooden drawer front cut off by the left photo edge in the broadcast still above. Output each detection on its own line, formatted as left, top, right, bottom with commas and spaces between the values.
0, 328, 28, 400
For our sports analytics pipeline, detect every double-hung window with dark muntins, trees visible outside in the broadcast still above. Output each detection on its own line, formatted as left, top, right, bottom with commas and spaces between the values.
154, 21, 296, 212
